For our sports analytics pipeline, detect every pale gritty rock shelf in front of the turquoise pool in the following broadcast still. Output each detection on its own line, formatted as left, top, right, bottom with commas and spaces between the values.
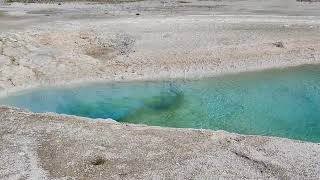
0, 107, 320, 179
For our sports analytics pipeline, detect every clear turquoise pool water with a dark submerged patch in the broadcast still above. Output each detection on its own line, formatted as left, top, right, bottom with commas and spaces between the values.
0, 65, 320, 142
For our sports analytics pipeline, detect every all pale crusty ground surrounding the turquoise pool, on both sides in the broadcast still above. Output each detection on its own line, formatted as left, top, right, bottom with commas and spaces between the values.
0, 0, 320, 179
